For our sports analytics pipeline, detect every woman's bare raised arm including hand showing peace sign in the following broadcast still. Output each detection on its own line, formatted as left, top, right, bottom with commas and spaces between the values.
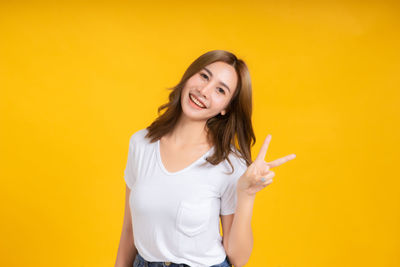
227, 135, 296, 267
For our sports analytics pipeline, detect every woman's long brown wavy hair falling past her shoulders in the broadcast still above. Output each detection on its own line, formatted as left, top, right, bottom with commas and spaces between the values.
146, 50, 256, 173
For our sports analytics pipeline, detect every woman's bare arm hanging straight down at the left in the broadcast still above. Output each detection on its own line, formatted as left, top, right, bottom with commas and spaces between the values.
115, 185, 137, 267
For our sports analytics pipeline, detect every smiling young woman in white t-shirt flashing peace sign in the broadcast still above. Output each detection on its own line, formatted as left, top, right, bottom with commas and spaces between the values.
115, 50, 295, 267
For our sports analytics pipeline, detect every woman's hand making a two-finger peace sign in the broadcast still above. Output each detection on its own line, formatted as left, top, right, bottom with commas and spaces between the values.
237, 134, 296, 196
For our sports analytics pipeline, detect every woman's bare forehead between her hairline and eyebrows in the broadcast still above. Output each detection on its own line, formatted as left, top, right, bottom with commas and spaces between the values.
205, 61, 237, 93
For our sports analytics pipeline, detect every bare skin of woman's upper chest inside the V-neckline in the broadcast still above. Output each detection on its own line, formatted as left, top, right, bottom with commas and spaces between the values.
160, 136, 211, 172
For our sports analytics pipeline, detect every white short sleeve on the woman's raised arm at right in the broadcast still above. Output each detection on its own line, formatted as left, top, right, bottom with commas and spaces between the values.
220, 160, 247, 215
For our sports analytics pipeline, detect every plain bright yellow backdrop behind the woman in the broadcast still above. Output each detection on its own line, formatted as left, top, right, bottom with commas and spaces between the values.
0, 1, 400, 267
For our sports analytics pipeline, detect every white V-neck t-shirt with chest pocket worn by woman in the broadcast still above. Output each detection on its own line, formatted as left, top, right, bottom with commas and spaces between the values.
124, 129, 247, 267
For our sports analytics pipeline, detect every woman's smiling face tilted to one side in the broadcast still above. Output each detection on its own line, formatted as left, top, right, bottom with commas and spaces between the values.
181, 61, 238, 120
